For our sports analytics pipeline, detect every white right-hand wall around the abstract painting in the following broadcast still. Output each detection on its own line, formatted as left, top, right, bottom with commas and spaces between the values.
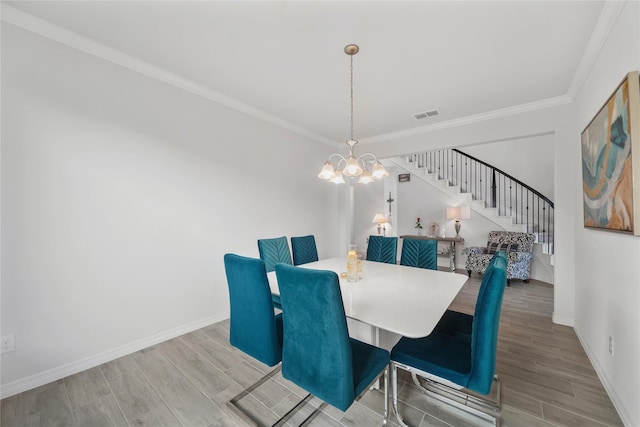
560, 2, 640, 426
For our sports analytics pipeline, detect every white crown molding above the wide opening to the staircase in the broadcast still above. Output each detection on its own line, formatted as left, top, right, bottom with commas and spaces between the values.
359, 95, 573, 144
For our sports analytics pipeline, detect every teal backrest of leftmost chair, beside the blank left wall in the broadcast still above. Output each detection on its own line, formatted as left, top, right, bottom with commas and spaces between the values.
224, 254, 282, 366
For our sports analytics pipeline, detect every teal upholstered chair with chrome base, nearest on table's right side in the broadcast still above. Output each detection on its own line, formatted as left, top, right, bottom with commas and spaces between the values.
391, 251, 507, 425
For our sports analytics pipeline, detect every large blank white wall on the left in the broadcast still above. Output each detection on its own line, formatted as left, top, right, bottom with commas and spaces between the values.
1, 23, 340, 397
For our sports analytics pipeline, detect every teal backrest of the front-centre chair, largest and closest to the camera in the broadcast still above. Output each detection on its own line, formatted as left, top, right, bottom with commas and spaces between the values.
276, 264, 355, 410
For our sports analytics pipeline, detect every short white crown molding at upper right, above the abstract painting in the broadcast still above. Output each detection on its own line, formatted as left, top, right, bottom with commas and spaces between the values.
567, 1, 626, 100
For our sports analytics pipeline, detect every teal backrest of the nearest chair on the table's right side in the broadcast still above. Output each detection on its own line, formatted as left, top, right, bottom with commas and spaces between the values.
466, 251, 507, 394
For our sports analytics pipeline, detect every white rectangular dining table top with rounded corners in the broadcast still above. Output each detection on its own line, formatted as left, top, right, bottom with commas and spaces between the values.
267, 257, 467, 338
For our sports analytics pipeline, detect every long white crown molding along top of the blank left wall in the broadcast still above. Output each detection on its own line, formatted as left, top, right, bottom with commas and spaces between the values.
0, 4, 336, 146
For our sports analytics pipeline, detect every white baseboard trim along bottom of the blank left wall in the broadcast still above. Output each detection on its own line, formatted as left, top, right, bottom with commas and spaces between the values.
0, 312, 229, 399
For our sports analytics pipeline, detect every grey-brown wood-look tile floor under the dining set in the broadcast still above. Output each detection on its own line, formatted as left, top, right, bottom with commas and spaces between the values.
1, 275, 622, 427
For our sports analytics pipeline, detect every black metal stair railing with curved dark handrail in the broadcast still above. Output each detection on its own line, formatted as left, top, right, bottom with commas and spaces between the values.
407, 149, 554, 253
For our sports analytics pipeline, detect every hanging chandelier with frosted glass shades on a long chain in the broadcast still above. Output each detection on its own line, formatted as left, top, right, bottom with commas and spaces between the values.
318, 44, 389, 184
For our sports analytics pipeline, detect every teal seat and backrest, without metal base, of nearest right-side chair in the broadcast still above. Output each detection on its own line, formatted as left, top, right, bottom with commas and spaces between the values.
391, 251, 507, 394
